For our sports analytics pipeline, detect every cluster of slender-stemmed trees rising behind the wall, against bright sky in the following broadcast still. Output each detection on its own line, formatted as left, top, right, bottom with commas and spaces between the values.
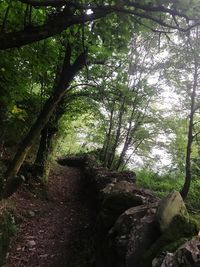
98, 34, 157, 169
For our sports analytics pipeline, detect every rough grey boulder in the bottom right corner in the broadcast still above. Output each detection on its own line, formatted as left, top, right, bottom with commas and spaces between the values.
152, 237, 200, 267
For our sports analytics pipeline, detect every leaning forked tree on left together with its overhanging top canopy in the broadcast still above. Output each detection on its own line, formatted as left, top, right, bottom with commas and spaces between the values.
0, 0, 199, 196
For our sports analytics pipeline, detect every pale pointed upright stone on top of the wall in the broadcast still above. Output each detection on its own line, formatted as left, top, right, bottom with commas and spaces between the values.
156, 191, 189, 232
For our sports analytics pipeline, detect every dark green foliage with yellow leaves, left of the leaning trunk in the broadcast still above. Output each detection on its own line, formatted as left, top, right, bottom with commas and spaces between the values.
0, 40, 58, 153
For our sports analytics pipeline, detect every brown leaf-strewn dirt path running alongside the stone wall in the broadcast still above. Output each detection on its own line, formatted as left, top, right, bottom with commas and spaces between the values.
4, 166, 94, 267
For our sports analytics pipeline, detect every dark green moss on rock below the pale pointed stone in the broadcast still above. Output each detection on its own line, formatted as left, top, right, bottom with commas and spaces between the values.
141, 215, 198, 266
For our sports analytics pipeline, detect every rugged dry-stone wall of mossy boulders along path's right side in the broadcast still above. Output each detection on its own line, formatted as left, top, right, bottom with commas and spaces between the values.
59, 156, 200, 267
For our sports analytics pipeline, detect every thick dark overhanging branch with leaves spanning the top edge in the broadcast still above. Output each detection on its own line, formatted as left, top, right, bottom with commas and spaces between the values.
0, 0, 199, 49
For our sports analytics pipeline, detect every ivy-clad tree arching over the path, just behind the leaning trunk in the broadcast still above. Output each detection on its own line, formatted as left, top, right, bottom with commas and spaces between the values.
35, 88, 99, 176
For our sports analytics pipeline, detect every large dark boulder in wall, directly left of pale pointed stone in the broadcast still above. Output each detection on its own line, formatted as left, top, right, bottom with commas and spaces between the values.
109, 203, 159, 267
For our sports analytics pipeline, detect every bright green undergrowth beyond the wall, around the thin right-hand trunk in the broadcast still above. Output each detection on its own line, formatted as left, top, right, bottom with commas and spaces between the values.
137, 169, 200, 214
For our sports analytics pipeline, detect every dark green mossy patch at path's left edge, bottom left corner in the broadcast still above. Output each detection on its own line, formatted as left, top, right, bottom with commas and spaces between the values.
0, 210, 17, 266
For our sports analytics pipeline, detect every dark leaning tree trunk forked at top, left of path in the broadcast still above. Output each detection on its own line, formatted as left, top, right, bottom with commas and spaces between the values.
3, 46, 86, 198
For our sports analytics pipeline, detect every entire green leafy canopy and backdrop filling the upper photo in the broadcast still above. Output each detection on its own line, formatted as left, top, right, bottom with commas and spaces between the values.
0, 0, 199, 201
